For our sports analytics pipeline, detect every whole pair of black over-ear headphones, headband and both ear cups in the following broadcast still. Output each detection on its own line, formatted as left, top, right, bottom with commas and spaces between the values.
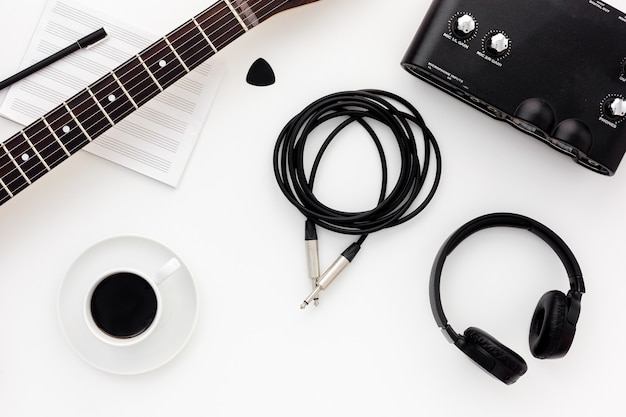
430, 213, 585, 385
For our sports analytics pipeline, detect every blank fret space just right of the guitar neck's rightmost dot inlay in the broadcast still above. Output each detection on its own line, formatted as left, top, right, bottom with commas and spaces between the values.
165, 20, 215, 71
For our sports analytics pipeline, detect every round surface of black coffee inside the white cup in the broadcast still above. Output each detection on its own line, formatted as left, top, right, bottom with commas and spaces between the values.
91, 272, 157, 339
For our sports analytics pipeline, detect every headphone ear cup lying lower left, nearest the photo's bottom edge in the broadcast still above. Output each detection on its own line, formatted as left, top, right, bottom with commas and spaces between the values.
461, 327, 528, 385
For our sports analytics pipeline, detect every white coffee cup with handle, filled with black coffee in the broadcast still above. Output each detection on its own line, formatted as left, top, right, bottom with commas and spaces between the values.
83, 258, 181, 347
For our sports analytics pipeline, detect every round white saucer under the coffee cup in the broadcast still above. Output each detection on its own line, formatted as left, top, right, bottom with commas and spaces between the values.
57, 236, 198, 375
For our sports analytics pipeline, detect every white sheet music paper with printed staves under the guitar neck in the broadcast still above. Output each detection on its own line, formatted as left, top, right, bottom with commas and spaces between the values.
0, 0, 224, 187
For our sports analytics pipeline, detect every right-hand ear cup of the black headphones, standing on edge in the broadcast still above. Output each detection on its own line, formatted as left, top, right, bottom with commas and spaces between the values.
528, 290, 576, 359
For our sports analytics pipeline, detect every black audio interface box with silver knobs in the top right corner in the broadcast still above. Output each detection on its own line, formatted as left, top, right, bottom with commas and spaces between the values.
402, 0, 626, 175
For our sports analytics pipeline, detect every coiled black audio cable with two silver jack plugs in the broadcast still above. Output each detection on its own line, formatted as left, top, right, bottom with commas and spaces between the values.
274, 90, 441, 308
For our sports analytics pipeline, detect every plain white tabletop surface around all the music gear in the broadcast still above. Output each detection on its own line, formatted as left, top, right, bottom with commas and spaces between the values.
0, 0, 626, 417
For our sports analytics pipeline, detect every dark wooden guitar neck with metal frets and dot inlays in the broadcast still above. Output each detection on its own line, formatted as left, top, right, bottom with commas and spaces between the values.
0, 0, 311, 205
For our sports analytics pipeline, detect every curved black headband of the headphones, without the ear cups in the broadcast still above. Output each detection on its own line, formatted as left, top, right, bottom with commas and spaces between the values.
430, 213, 585, 342
